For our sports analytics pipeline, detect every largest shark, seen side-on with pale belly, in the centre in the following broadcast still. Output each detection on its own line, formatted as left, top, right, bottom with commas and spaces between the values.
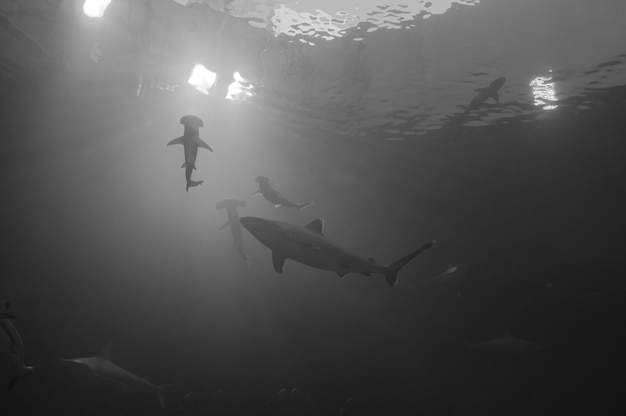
240, 217, 435, 286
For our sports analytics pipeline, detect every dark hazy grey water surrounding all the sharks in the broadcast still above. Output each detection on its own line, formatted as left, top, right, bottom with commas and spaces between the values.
0, 0, 626, 416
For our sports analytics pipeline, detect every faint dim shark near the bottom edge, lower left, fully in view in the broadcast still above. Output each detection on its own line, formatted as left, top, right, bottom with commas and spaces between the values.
62, 342, 174, 408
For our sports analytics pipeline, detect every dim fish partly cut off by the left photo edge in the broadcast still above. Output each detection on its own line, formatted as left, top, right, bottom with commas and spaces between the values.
0, 301, 35, 390
